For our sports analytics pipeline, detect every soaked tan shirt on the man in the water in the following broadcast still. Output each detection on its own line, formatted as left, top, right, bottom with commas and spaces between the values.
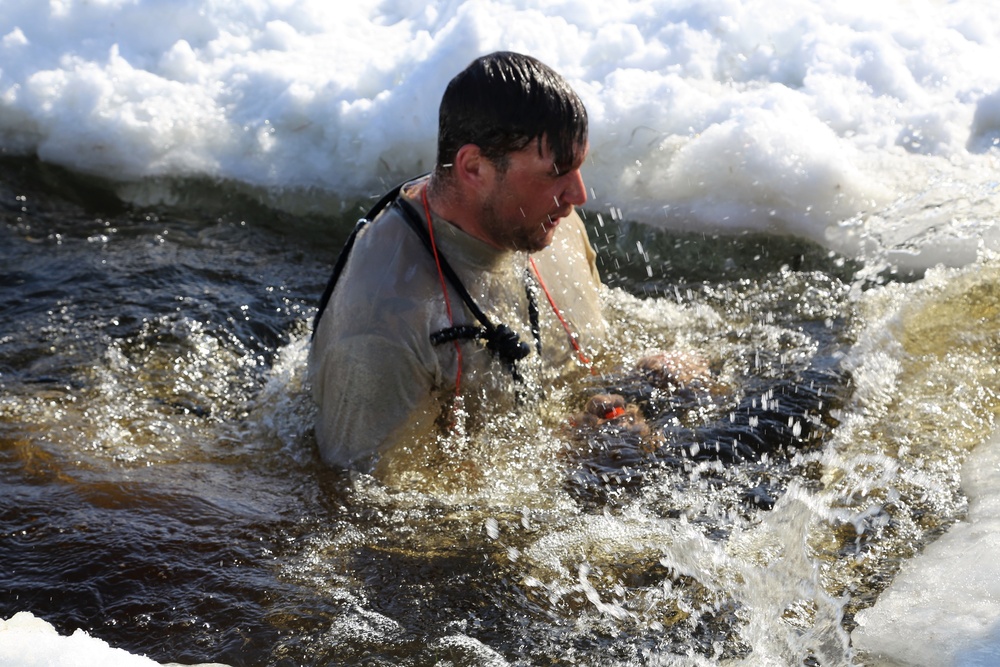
309, 180, 607, 471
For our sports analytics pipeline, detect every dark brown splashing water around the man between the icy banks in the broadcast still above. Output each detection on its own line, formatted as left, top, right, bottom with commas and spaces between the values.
0, 158, 1000, 666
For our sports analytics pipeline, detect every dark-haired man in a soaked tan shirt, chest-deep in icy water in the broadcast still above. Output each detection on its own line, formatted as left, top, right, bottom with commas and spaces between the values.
309, 52, 607, 471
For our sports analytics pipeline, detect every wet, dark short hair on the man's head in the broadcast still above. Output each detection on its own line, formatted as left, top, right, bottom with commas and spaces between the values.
435, 51, 588, 176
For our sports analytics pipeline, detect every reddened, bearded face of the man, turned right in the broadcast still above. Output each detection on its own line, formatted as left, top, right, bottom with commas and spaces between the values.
480, 138, 587, 252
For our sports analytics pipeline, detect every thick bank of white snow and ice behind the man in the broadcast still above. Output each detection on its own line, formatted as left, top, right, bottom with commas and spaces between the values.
0, 0, 1000, 265
